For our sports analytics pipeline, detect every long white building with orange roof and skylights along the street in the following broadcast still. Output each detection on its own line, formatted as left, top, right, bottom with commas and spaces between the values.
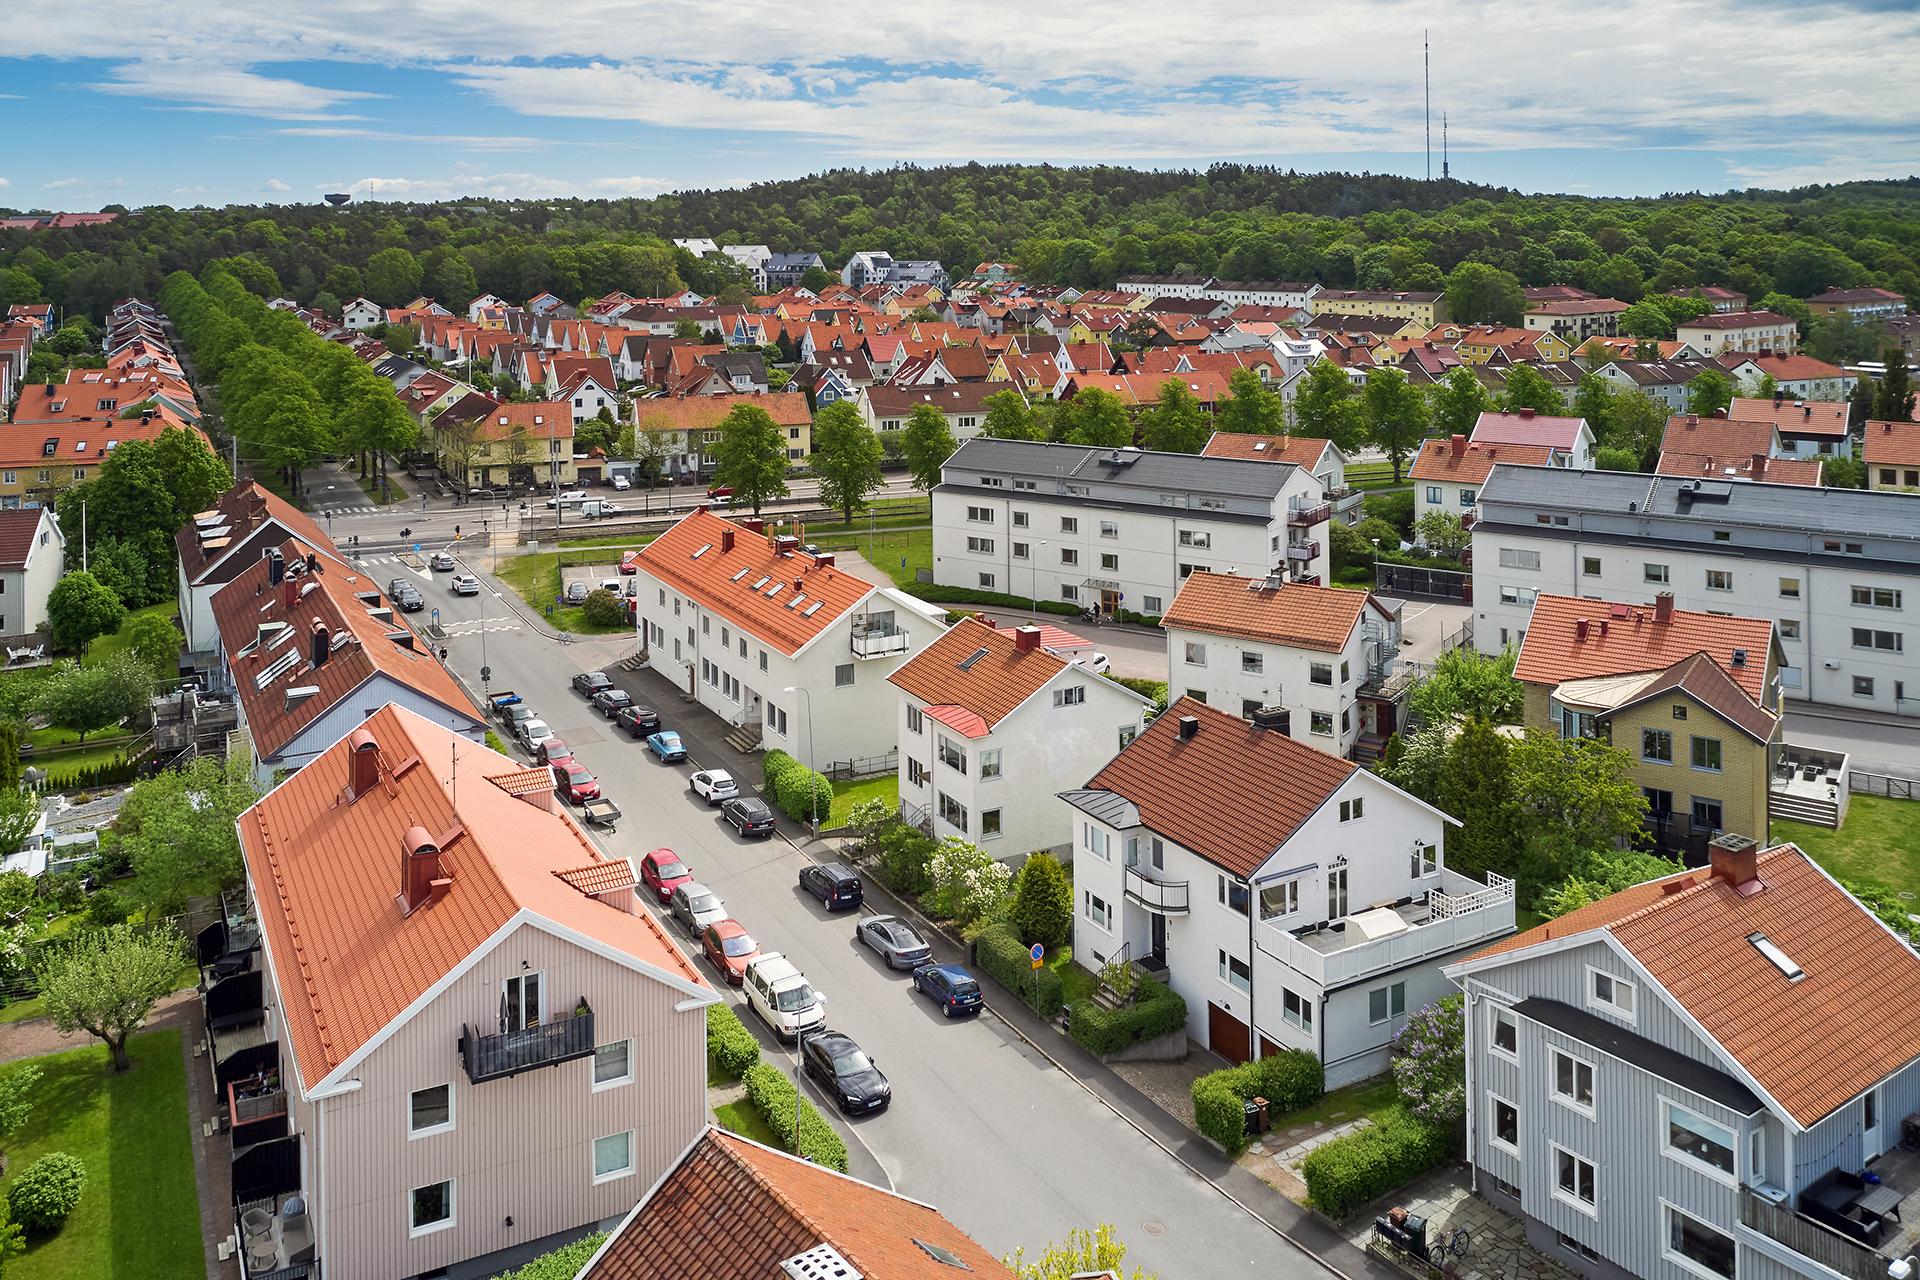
634, 509, 947, 771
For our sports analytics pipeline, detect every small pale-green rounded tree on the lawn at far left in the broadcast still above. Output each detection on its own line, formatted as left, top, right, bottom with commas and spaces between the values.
35, 925, 186, 1073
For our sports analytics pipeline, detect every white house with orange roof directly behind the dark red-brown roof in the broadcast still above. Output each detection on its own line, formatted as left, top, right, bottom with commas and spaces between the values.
1160, 574, 1400, 756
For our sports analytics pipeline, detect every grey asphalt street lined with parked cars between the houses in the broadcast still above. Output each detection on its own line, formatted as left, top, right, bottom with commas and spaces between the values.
405, 560, 1325, 1280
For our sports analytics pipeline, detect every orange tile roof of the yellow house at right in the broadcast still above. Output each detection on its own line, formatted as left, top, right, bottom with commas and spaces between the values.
1513, 595, 1778, 702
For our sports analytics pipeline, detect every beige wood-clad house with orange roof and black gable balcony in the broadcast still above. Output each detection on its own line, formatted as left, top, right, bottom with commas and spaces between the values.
198, 706, 716, 1280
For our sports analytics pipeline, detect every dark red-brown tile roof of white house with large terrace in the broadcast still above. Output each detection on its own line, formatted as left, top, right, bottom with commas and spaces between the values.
1087, 699, 1359, 877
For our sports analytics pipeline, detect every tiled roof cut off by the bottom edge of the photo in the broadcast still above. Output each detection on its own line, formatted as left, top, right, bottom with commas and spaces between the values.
580, 1128, 1016, 1280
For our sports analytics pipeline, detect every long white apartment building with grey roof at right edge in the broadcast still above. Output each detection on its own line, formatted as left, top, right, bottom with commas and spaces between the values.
1473, 464, 1920, 714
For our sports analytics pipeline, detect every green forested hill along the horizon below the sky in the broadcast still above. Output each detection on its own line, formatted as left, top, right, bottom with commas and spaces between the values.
0, 165, 1920, 315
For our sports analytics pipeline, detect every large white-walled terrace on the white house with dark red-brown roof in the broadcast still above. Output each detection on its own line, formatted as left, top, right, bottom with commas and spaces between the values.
1261, 869, 1513, 986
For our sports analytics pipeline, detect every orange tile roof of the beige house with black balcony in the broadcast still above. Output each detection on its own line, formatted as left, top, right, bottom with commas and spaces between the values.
238, 704, 705, 1088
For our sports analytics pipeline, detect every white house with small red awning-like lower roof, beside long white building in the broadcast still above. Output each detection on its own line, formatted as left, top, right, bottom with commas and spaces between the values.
891, 618, 1150, 858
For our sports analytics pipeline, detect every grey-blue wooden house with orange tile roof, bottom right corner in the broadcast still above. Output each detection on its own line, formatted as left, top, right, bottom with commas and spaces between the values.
1446, 835, 1920, 1280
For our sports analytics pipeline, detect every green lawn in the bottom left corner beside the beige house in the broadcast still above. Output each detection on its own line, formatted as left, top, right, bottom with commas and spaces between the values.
0, 1031, 205, 1280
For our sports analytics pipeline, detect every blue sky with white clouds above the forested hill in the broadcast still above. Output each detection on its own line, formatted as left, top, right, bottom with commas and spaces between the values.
0, 0, 1920, 210
